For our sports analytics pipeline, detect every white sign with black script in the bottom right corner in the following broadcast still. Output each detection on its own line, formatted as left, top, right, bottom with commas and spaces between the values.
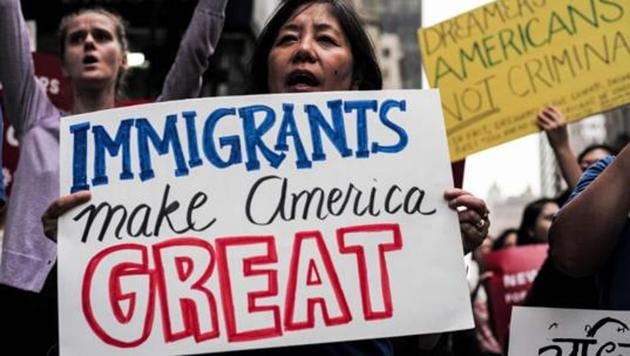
509, 306, 630, 356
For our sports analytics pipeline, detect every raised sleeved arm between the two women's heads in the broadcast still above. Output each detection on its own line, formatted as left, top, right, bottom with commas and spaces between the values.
158, 0, 227, 101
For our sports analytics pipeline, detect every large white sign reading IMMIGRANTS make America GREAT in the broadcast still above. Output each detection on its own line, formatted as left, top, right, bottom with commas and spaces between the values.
59, 90, 473, 355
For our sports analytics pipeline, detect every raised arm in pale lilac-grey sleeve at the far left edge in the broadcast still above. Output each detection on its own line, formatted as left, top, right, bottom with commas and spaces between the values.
0, 0, 57, 138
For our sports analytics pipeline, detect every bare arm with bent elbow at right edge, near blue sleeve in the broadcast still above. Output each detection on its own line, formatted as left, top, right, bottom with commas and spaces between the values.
549, 145, 630, 277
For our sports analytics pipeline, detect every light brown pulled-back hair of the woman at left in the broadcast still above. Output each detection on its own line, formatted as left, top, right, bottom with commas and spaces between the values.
58, 7, 129, 92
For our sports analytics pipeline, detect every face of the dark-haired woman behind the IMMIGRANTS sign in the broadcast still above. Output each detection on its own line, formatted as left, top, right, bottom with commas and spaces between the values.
267, 3, 355, 93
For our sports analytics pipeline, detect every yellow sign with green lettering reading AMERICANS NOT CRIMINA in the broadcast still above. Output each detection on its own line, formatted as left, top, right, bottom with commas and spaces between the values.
418, 0, 630, 160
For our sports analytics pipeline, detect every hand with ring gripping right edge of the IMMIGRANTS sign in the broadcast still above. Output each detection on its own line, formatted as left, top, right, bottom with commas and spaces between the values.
444, 188, 490, 253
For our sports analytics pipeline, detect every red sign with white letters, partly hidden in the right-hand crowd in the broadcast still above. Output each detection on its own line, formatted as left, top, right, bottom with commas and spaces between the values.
484, 244, 549, 345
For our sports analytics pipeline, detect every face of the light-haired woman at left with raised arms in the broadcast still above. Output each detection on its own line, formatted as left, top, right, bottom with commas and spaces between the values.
64, 12, 127, 88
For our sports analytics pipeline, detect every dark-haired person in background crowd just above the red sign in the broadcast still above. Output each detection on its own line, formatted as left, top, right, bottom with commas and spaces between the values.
516, 198, 558, 246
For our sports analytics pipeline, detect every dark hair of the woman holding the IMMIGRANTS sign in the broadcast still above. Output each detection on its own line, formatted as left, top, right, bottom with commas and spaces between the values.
250, 0, 383, 94
